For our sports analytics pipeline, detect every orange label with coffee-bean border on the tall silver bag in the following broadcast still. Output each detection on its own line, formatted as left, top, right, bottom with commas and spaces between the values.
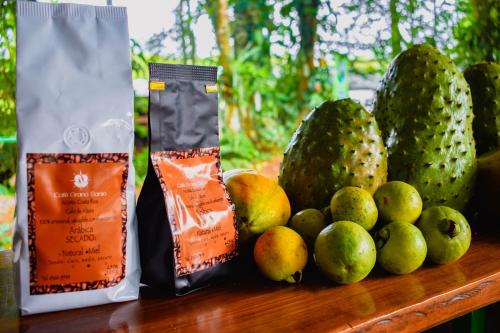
27, 153, 128, 294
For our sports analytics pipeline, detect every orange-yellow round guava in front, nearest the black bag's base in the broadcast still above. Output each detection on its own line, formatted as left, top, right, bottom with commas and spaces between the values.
253, 226, 307, 283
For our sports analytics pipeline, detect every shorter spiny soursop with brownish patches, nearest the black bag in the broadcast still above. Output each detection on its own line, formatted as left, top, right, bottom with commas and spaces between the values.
279, 99, 387, 212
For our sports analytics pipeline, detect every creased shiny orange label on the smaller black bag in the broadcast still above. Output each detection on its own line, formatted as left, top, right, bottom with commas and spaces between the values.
151, 148, 237, 276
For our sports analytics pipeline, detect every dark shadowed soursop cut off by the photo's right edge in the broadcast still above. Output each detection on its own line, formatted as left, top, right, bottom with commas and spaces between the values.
464, 62, 500, 155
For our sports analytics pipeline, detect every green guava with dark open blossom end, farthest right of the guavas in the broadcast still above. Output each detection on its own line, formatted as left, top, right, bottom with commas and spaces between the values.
417, 206, 471, 264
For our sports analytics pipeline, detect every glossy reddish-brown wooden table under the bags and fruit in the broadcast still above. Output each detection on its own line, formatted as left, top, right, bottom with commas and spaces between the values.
0, 233, 500, 333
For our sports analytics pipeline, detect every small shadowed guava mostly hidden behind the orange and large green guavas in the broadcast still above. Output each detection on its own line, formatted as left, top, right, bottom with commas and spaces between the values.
288, 208, 328, 248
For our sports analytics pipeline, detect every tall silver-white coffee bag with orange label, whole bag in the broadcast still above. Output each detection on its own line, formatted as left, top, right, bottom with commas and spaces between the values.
13, 1, 140, 314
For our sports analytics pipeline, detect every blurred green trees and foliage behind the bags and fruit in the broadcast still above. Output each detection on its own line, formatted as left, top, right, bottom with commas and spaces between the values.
0, 0, 500, 249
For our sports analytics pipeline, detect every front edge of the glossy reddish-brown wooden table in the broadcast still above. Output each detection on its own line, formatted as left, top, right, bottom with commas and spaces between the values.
343, 272, 500, 333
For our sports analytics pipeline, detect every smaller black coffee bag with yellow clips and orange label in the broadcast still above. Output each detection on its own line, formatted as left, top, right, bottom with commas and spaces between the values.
137, 63, 238, 295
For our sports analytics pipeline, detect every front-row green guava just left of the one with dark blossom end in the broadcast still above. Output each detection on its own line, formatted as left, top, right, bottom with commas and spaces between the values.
375, 222, 427, 274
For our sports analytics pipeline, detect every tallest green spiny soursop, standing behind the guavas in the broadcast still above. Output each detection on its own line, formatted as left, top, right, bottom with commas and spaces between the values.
374, 44, 476, 210
